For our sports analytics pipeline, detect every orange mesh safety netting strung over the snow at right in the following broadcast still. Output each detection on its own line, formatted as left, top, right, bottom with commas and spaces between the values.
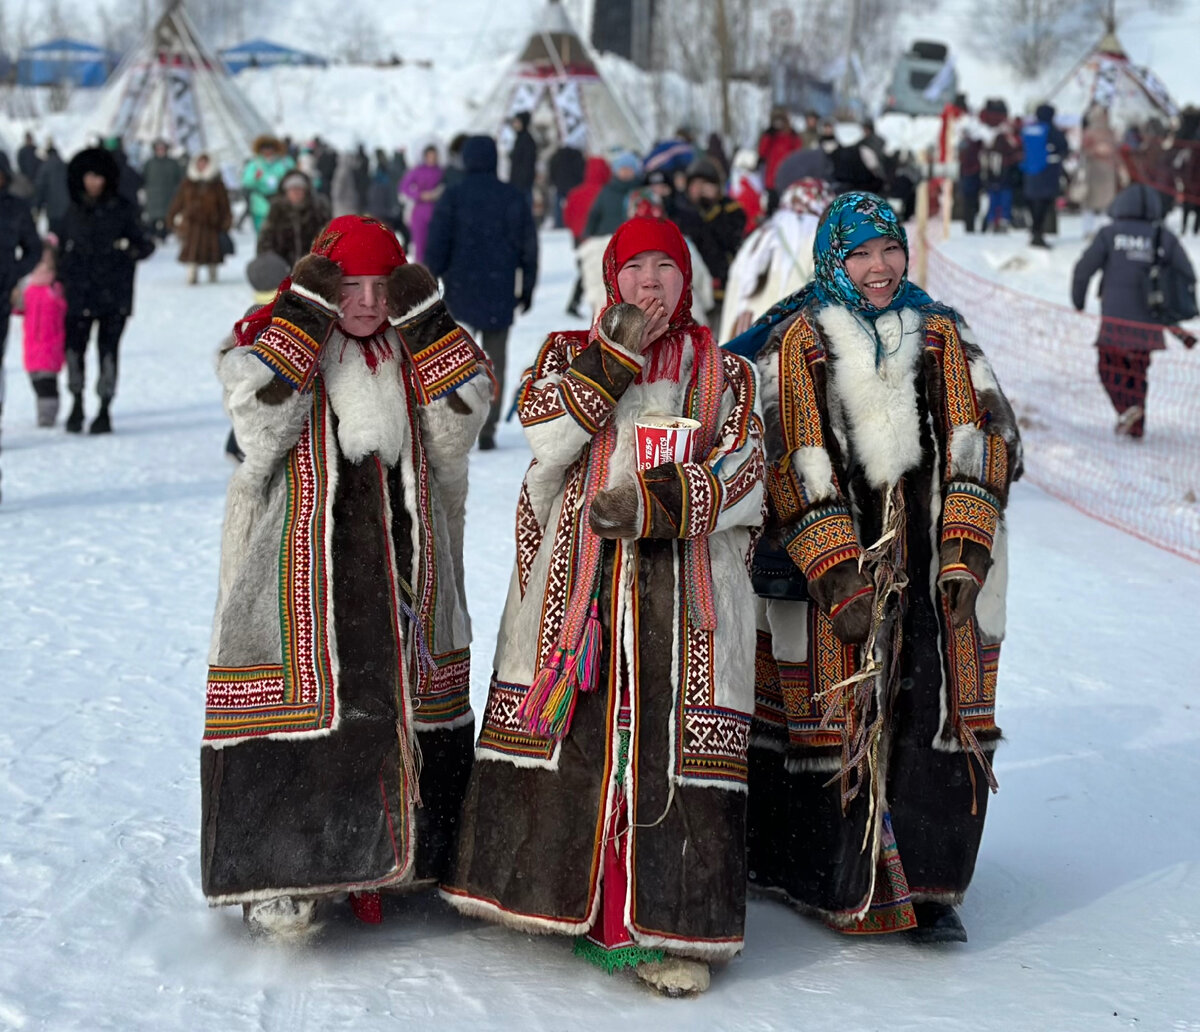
923, 235, 1200, 563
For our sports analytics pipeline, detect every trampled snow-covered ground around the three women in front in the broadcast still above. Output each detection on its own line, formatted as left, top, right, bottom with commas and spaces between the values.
0, 233, 1200, 1032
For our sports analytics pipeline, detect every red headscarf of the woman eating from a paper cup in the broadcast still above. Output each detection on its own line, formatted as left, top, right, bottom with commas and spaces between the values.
593, 216, 714, 383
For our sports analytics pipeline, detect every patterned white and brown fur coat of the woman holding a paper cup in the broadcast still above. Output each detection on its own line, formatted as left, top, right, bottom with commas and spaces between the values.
444, 321, 764, 958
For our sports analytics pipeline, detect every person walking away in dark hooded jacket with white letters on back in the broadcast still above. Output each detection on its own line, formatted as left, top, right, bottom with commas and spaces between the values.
1070, 182, 1196, 439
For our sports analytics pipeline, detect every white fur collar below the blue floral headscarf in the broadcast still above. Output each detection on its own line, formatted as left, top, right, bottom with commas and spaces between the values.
817, 305, 924, 488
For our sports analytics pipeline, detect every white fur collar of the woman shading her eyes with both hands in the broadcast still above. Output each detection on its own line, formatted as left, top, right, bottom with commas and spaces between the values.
320, 328, 412, 466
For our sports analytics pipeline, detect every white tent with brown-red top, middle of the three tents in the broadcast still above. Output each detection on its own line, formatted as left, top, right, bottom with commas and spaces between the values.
476, 0, 649, 154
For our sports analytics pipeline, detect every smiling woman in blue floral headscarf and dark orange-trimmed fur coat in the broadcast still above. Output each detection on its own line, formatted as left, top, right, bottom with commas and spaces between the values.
732, 192, 1020, 941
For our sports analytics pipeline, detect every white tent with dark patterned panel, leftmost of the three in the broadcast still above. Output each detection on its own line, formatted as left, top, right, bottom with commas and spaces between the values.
89, 0, 269, 169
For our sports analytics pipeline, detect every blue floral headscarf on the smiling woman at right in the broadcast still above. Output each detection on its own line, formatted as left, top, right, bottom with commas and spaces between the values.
725, 191, 953, 359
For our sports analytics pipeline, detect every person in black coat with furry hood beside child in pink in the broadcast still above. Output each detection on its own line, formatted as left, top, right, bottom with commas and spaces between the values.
59, 148, 154, 433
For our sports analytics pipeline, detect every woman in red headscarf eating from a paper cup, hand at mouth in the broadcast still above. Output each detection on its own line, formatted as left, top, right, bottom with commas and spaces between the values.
444, 217, 763, 995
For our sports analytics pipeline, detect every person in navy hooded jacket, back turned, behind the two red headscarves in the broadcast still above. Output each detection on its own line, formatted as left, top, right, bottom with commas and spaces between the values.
425, 136, 538, 451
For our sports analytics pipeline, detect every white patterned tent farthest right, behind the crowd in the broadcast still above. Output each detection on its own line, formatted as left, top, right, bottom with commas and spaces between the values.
1050, 32, 1177, 133
